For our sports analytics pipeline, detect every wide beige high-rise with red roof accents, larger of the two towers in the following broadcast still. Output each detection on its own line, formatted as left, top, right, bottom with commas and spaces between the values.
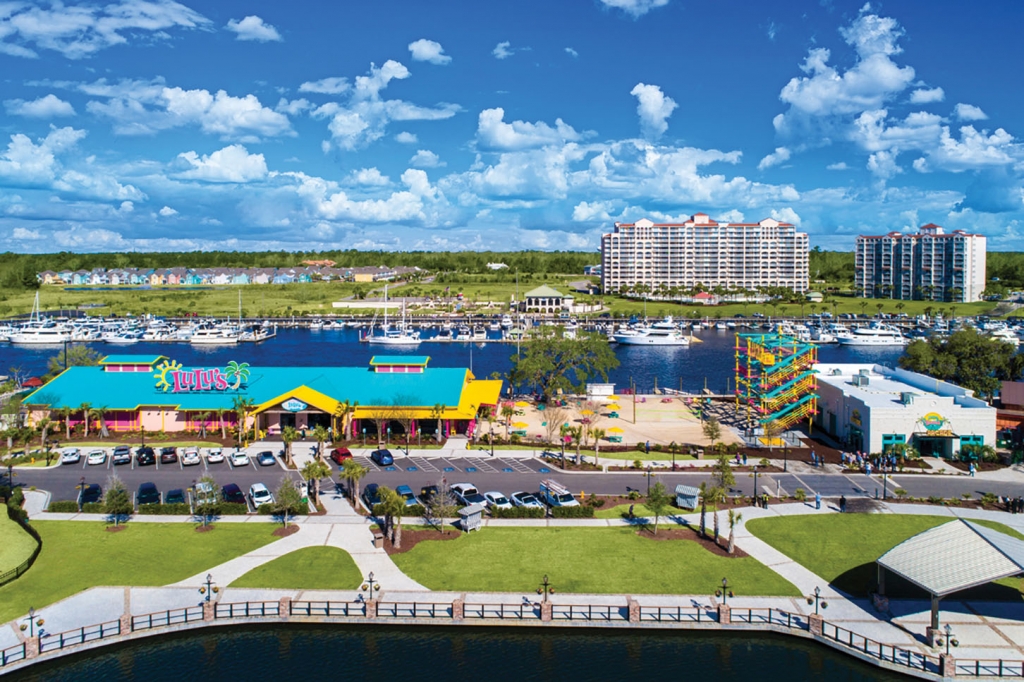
601, 213, 808, 293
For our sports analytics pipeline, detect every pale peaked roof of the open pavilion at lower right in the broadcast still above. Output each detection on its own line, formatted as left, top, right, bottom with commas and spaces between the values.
878, 519, 1024, 597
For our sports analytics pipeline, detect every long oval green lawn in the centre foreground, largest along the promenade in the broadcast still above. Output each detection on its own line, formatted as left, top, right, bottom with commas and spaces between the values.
392, 527, 800, 596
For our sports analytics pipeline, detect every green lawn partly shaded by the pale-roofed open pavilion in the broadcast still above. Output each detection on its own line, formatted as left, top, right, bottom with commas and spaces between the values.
746, 514, 1021, 598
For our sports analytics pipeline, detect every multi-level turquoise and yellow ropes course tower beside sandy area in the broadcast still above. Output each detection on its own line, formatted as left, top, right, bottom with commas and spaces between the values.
735, 334, 818, 431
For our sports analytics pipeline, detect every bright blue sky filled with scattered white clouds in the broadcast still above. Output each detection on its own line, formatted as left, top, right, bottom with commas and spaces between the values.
0, 0, 1024, 252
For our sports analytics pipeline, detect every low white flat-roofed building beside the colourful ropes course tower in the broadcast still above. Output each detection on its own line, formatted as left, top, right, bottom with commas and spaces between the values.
814, 364, 995, 457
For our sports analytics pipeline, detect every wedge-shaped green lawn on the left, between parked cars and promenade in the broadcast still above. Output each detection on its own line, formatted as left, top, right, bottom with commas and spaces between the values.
0, 521, 275, 623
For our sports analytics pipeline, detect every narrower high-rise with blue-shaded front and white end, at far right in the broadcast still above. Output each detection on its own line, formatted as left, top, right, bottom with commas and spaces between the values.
854, 223, 985, 303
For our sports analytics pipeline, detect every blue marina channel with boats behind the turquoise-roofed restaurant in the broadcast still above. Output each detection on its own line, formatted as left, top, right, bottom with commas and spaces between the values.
0, 329, 903, 393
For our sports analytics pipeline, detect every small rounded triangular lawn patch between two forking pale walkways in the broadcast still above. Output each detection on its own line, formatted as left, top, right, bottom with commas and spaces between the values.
231, 547, 362, 590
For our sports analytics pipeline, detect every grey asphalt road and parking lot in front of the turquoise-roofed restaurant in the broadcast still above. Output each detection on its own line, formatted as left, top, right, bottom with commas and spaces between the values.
14, 451, 1024, 500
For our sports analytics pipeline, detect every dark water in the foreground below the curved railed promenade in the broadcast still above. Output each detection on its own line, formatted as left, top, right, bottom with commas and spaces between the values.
9, 626, 908, 682
